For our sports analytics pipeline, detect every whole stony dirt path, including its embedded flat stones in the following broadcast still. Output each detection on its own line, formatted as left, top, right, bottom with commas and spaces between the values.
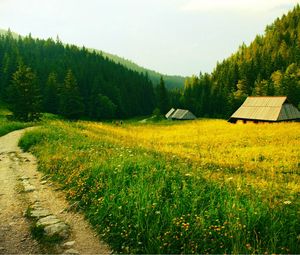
0, 130, 111, 254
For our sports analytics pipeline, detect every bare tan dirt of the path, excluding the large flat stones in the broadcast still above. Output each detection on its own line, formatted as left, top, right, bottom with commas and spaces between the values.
0, 130, 111, 254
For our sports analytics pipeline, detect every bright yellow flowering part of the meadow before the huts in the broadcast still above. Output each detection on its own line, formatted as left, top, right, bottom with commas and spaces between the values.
82, 120, 300, 192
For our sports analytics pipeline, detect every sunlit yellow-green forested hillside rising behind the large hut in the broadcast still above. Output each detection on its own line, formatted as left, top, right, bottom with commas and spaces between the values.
177, 5, 300, 117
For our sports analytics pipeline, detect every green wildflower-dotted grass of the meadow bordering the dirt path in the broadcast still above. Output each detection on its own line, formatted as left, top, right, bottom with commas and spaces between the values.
20, 122, 300, 253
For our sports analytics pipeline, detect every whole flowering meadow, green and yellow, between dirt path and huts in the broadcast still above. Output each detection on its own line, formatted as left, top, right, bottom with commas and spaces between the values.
20, 120, 300, 254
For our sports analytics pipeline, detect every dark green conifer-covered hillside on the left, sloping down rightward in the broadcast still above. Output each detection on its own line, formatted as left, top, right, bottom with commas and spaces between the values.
0, 32, 155, 119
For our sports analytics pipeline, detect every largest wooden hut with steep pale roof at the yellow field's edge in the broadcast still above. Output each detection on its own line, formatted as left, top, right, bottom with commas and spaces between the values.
228, 96, 300, 123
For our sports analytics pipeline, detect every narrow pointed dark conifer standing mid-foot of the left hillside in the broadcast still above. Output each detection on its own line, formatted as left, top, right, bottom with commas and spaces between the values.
60, 69, 84, 119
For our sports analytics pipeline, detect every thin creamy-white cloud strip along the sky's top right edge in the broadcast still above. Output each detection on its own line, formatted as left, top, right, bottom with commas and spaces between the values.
181, 0, 300, 12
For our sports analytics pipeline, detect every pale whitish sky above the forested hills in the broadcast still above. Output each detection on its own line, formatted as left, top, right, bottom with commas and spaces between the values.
0, 0, 300, 76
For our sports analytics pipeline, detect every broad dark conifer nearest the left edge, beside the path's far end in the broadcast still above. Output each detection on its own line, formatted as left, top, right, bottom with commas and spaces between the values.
8, 64, 41, 121
